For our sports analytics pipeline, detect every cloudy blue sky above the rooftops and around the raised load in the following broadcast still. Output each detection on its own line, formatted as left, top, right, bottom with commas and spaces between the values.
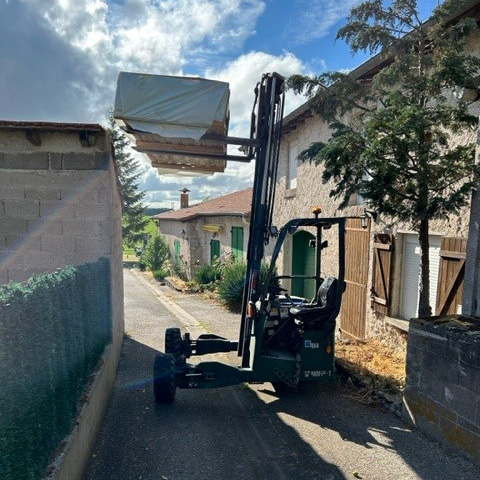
0, 0, 438, 208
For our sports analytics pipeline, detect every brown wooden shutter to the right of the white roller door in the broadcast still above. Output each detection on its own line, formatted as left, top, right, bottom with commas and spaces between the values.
435, 237, 467, 315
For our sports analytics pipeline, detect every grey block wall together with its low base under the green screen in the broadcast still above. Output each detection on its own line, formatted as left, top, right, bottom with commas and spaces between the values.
0, 126, 124, 480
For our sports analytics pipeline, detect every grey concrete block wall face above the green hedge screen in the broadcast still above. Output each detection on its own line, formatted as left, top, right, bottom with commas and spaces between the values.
0, 131, 116, 283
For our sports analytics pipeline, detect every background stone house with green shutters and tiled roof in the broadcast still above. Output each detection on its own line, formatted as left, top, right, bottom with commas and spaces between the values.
153, 188, 252, 278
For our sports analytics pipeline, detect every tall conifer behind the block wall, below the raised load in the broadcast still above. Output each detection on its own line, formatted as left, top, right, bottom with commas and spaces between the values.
108, 116, 148, 247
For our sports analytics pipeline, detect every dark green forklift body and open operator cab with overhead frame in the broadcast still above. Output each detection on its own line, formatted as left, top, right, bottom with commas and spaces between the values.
251, 218, 345, 390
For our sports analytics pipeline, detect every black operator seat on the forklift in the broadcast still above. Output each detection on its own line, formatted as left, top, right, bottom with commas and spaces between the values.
290, 277, 338, 327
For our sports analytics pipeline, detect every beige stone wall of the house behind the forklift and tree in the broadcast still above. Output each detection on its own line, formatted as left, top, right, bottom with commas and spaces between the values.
274, 62, 480, 343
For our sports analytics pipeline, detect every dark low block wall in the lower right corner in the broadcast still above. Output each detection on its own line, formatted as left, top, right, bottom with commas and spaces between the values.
404, 316, 480, 464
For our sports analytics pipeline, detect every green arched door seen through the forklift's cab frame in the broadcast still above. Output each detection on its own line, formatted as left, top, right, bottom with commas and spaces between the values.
292, 231, 316, 299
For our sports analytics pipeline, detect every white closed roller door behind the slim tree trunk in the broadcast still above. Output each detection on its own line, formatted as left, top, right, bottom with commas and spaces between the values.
400, 235, 442, 319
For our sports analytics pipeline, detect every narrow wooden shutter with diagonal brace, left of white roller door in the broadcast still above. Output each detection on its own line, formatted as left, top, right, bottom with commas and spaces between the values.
371, 233, 393, 315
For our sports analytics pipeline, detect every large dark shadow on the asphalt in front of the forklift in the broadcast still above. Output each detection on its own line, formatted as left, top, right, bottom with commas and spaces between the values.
86, 339, 345, 480
